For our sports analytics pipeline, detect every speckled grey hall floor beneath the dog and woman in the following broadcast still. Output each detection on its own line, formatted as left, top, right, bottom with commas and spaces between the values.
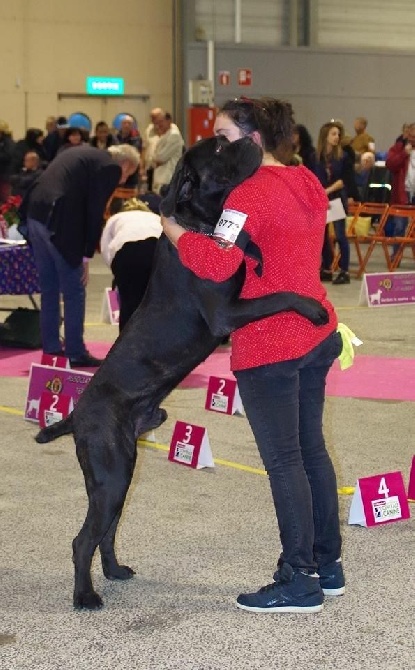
0, 247, 415, 670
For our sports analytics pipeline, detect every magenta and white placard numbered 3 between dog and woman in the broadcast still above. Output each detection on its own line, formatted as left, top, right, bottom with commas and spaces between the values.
169, 421, 215, 470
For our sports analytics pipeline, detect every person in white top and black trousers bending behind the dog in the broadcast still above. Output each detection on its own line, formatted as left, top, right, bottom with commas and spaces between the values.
100, 198, 163, 332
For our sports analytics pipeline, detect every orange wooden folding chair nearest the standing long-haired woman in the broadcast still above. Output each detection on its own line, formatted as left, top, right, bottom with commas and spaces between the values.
348, 202, 389, 279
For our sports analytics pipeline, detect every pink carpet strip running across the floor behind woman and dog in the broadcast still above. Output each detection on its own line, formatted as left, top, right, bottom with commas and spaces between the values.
0, 342, 415, 401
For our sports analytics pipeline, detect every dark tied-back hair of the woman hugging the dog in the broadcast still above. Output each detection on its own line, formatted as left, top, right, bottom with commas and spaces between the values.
218, 98, 294, 163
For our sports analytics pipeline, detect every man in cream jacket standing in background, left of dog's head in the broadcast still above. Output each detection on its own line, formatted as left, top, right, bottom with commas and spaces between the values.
153, 112, 184, 193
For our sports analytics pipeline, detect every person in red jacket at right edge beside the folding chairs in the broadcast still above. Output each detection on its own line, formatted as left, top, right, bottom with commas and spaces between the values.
386, 123, 415, 259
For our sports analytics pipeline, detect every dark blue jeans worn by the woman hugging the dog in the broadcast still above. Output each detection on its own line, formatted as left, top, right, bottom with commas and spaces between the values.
235, 332, 342, 570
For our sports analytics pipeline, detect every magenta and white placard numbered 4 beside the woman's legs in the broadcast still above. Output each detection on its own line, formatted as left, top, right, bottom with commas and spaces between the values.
349, 472, 410, 527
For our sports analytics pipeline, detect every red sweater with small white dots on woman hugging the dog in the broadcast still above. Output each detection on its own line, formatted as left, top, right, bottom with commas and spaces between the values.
178, 166, 337, 370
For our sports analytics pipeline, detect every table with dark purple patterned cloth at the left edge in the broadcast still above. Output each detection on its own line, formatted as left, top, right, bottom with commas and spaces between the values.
0, 244, 40, 308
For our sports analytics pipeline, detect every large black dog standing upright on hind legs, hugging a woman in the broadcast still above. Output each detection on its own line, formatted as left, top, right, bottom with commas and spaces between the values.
36, 138, 327, 609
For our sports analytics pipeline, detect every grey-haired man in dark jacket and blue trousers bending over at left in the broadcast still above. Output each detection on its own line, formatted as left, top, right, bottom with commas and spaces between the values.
25, 145, 140, 367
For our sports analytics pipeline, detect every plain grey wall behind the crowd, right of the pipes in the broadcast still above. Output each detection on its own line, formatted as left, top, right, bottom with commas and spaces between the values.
183, 42, 415, 150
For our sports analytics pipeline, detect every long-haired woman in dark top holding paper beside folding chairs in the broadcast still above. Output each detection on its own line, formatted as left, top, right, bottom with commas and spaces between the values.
313, 121, 356, 285
